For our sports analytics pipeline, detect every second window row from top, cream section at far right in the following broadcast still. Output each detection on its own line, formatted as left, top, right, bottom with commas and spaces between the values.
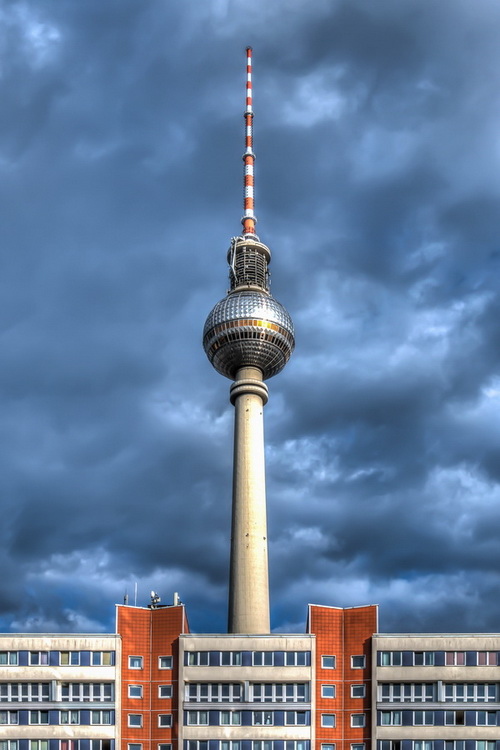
378, 682, 500, 703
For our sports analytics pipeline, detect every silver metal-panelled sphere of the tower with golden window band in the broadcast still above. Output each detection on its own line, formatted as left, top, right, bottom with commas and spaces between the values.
203, 290, 295, 380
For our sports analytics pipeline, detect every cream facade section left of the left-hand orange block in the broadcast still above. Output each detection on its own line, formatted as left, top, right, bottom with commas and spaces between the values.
0, 634, 121, 750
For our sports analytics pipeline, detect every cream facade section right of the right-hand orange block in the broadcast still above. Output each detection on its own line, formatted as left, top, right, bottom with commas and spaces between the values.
372, 634, 500, 750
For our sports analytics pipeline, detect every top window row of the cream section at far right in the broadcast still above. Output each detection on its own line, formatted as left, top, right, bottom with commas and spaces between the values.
377, 651, 500, 667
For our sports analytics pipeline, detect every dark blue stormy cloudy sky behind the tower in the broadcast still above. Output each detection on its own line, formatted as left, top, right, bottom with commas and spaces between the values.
0, 0, 500, 632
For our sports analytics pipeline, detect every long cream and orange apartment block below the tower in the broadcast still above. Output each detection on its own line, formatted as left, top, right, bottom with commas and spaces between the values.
0, 604, 500, 750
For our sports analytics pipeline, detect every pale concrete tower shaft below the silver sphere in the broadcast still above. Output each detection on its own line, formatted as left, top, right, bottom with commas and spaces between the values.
228, 367, 270, 634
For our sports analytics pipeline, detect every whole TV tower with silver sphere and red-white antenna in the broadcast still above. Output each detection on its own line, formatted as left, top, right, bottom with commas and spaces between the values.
203, 47, 295, 634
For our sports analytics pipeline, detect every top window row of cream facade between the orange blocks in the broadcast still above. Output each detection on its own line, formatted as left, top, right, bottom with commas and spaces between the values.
184, 651, 311, 667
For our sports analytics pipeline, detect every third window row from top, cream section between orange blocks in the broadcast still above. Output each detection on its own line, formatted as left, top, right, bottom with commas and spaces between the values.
184, 711, 311, 726
